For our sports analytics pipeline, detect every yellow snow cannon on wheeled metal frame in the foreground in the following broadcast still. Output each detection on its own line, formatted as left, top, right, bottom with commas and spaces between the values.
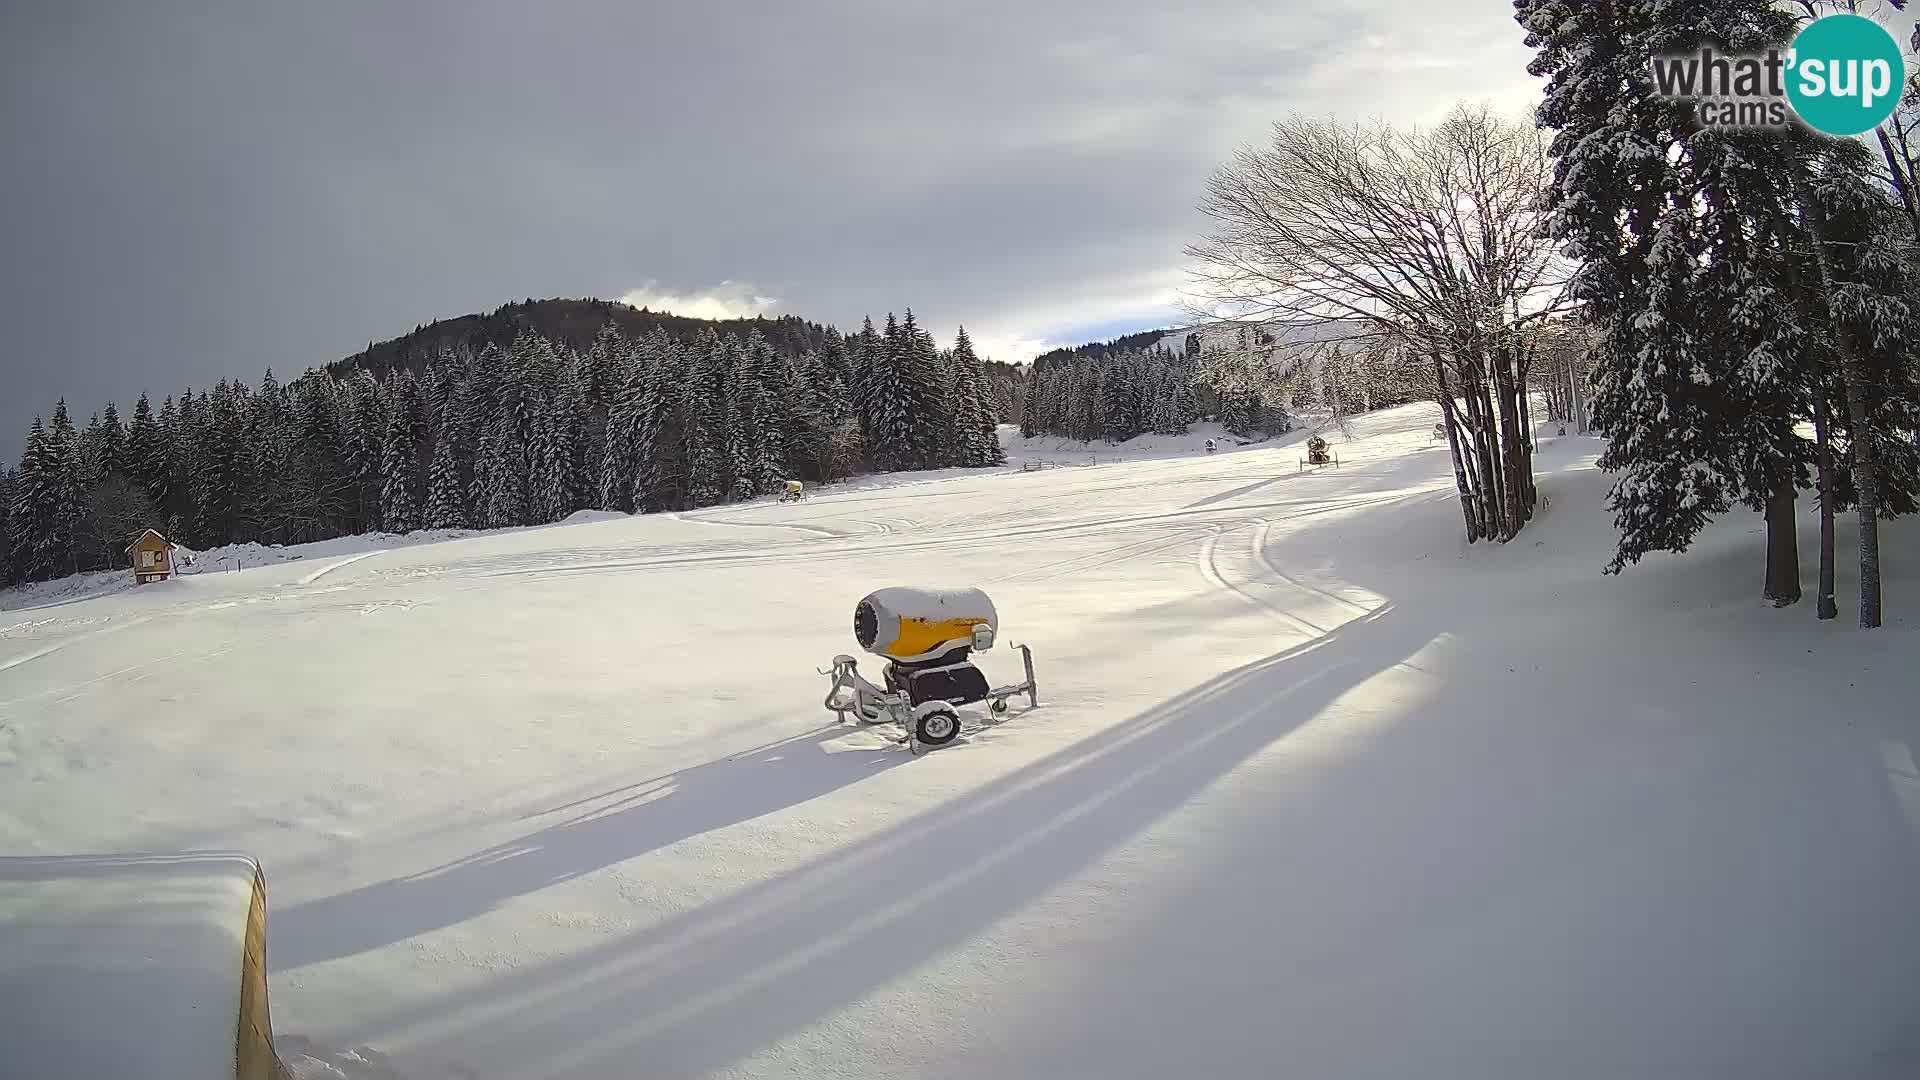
820, 588, 1041, 753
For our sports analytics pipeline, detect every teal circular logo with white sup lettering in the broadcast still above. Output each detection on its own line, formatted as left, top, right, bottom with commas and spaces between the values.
1788, 15, 1907, 135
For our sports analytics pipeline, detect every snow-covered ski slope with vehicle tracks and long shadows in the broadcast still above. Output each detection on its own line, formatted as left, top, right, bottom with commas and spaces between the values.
0, 407, 1920, 1080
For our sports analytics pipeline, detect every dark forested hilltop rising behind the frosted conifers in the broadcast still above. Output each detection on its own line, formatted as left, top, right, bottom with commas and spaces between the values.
326, 300, 835, 379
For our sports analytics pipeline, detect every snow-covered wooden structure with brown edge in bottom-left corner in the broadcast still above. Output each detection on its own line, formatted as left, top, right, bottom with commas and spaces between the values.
0, 855, 288, 1080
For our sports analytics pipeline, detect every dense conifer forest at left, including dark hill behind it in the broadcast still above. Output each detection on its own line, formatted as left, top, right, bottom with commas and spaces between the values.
0, 302, 1020, 582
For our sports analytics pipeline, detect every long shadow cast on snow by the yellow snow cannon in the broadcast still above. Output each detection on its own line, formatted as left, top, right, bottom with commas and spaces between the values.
273, 724, 904, 967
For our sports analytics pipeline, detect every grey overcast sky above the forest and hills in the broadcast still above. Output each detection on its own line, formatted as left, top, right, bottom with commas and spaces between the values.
0, 0, 1538, 440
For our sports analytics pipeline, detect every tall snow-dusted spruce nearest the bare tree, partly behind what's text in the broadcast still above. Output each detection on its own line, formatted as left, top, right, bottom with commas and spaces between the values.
1515, 0, 1807, 580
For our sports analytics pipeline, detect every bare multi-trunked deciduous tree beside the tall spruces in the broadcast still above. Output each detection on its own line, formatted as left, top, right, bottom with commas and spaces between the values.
1188, 106, 1567, 542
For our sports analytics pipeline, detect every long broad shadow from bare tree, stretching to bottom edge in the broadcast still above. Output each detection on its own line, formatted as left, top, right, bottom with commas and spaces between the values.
369, 605, 1440, 1076
